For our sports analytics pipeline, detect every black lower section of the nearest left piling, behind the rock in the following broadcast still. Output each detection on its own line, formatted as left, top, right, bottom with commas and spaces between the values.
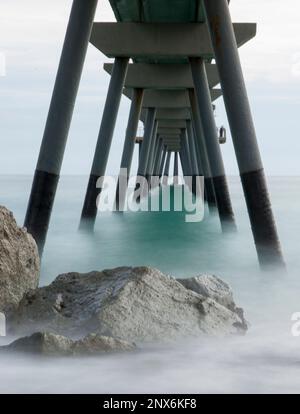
24, 170, 59, 256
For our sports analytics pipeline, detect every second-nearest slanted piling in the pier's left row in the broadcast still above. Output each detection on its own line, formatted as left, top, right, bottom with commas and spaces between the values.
80, 58, 129, 230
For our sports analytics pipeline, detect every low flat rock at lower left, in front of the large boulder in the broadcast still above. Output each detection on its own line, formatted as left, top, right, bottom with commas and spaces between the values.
0, 332, 136, 356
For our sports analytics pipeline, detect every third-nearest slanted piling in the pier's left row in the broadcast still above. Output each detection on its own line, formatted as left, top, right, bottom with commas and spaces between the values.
115, 88, 144, 211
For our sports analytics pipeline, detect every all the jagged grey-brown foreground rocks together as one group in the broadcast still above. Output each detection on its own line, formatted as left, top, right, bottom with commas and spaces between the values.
0, 207, 247, 356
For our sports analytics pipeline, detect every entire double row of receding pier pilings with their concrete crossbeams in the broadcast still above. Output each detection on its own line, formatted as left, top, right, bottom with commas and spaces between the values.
25, 0, 284, 267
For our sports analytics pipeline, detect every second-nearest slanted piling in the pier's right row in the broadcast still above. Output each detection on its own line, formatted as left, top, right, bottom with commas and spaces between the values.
190, 58, 236, 231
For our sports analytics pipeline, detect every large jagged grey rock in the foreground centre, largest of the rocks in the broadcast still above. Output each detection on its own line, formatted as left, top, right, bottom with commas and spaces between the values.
8, 267, 247, 342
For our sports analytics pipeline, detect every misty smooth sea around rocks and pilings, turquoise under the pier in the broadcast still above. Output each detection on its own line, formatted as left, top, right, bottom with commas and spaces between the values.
0, 176, 300, 392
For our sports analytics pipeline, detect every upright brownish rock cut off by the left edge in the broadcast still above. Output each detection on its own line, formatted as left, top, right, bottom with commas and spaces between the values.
0, 206, 40, 312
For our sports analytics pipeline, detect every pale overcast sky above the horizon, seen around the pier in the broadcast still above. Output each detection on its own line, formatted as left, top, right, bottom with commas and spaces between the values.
0, 0, 300, 175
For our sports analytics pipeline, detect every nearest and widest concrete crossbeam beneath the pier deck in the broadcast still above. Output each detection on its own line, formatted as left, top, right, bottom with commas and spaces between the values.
90, 22, 256, 59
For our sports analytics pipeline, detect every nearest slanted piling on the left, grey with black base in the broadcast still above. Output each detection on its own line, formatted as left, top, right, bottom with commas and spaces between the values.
24, 0, 98, 255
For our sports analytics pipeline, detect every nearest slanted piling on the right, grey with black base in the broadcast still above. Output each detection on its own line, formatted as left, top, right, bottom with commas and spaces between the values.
204, 0, 284, 267
